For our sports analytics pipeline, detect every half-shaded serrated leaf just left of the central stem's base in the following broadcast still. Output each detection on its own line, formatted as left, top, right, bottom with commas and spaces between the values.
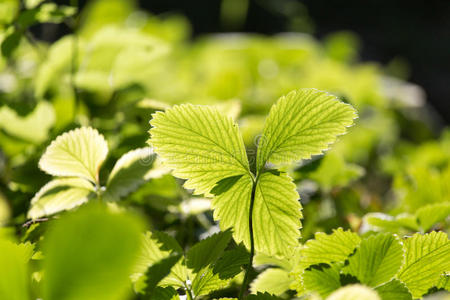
192, 247, 248, 295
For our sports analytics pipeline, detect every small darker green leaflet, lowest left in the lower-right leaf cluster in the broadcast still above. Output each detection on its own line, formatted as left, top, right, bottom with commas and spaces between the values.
302, 264, 341, 298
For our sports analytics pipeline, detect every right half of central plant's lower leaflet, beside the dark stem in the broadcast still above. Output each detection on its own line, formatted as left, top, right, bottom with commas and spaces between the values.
253, 172, 302, 257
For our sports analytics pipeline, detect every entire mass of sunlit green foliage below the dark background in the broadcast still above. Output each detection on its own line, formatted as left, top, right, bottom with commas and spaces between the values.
0, 0, 450, 300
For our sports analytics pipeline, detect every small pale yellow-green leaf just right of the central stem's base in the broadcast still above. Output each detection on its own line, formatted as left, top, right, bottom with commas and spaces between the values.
250, 268, 292, 295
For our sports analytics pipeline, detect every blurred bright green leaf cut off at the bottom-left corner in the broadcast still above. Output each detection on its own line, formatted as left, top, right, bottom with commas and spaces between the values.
0, 238, 33, 300
